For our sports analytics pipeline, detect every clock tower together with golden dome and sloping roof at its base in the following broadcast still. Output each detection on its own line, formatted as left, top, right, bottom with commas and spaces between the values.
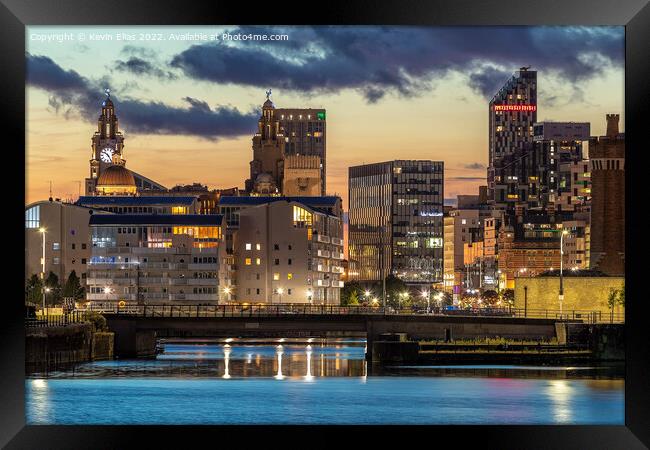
85, 90, 166, 195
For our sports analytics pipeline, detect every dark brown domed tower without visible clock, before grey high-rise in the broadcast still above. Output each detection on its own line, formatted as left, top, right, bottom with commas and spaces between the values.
246, 89, 285, 195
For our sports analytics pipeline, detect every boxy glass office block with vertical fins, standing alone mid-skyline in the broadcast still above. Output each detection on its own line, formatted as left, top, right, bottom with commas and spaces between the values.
348, 160, 444, 284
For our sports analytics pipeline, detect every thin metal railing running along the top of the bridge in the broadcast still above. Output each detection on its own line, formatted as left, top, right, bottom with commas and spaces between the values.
83, 304, 625, 323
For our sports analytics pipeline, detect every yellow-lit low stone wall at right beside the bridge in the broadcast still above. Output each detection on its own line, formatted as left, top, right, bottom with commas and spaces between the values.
515, 277, 625, 318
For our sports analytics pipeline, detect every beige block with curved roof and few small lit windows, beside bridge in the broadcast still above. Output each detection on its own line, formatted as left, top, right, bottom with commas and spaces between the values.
232, 199, 344, 305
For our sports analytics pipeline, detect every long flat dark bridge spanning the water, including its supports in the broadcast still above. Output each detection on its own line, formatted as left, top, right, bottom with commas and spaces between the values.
103, 305, 595, 359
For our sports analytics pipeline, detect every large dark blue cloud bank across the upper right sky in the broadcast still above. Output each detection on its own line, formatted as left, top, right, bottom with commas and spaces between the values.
170, 26, 624, 103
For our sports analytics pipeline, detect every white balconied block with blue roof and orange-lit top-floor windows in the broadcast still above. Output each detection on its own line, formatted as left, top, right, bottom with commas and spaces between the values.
86, 214, 229, 307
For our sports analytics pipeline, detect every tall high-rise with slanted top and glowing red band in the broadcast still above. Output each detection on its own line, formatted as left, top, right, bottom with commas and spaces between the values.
487, 67, 537, 209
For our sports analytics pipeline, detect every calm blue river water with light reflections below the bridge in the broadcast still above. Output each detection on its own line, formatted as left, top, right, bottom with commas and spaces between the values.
26, 339, 624, 424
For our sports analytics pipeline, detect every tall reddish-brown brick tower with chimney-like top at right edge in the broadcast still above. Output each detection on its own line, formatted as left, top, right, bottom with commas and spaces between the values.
589, 114, 625, 275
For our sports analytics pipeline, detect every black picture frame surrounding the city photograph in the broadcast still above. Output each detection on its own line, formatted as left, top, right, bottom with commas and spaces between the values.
0, 0, 650, 449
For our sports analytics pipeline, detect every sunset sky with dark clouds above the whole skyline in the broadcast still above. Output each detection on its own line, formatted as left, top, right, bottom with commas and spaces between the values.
26, 26, 625, 208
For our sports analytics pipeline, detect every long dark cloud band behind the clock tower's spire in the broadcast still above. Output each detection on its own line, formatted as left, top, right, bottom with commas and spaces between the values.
27, 53, 258, 139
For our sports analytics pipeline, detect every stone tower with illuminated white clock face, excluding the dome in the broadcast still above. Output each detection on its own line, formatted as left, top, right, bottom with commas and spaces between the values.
86, 89, 124, 195
